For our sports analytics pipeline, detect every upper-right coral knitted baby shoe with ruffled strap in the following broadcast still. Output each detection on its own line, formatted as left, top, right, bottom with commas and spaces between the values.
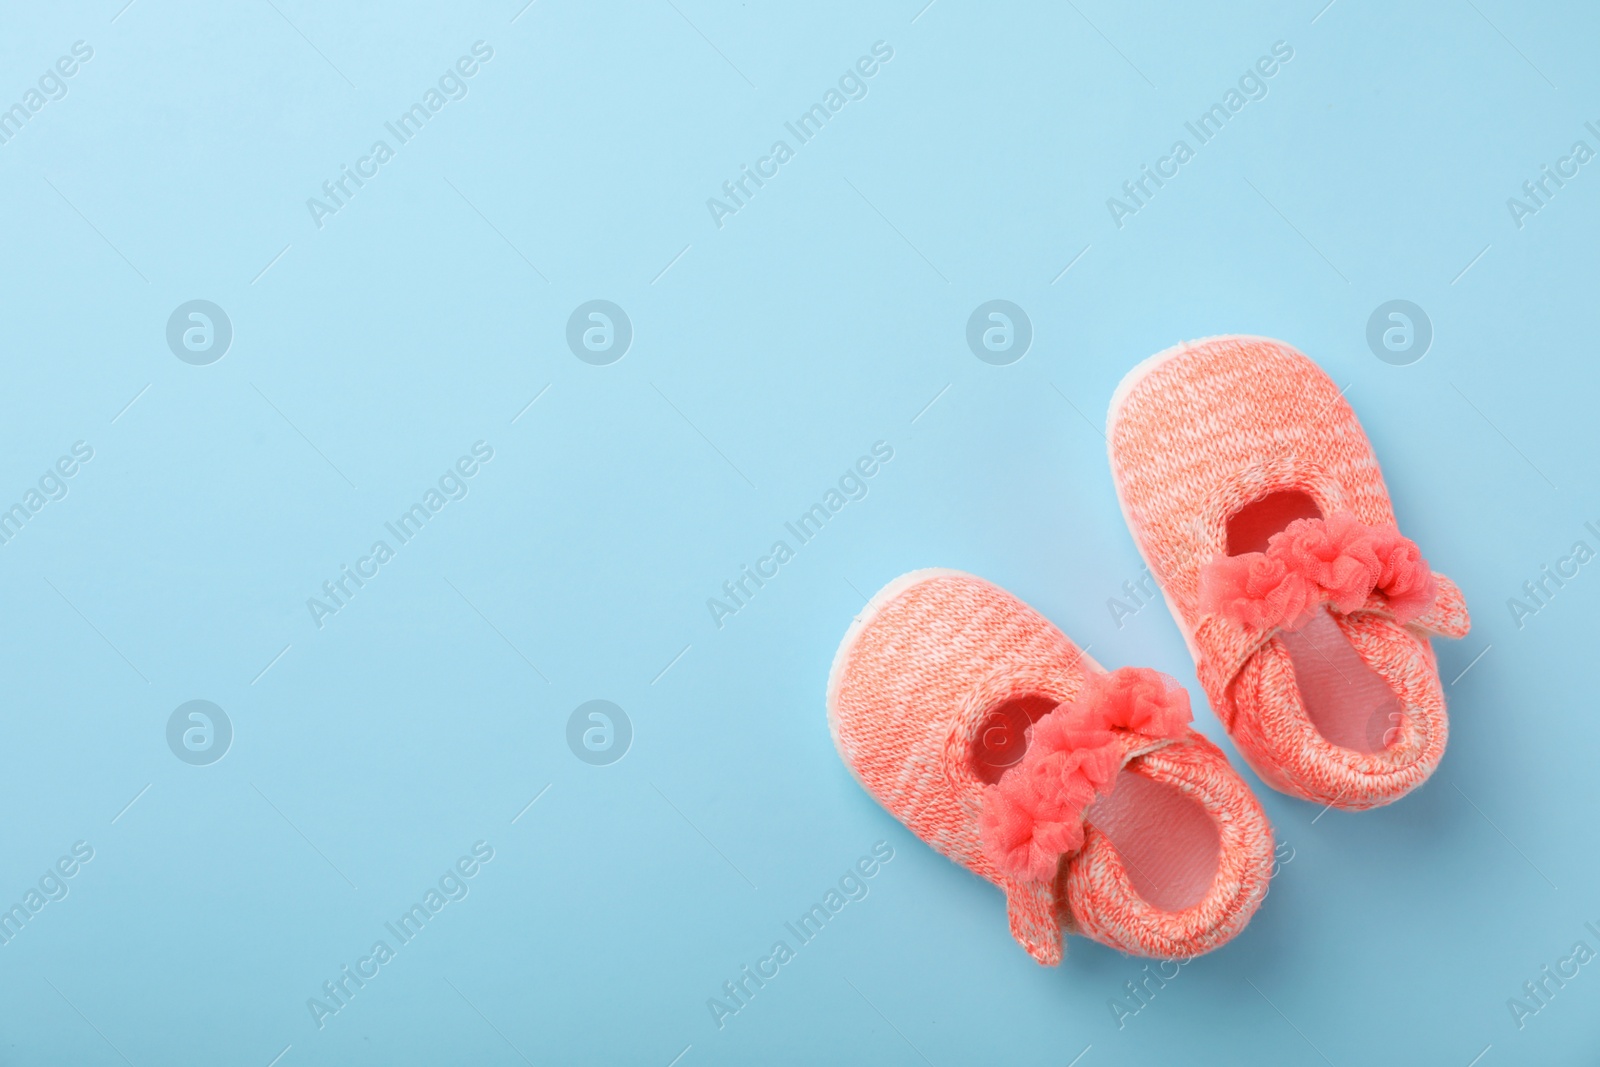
1106, 336, 1469, 808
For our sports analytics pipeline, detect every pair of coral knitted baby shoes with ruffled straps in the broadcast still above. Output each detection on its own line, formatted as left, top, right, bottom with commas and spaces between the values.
827, 336, 1469, 965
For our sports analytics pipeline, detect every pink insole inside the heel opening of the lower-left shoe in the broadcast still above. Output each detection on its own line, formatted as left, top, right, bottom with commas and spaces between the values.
1088, 769, 1222, 912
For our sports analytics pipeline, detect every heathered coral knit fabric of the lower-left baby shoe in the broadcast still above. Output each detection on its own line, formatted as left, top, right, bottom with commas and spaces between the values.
829, 571, 1272, 965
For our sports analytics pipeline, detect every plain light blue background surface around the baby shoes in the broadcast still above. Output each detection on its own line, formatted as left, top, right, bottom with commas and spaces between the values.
0, 0, 1600, 1067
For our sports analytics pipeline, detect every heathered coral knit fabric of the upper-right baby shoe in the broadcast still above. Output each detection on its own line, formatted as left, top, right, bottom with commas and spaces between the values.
1107, 338, 1469, 808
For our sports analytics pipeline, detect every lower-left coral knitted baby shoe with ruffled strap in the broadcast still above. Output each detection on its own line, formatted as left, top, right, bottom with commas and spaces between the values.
827, 569, 1272, 965
